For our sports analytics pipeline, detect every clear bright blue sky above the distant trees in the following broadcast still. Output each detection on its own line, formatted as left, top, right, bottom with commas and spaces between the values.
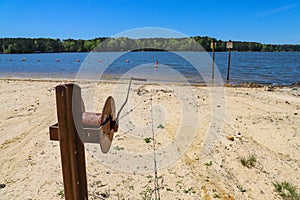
0, 0, 300, 44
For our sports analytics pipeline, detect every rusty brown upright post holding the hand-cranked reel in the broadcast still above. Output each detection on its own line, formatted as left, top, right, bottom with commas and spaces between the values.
54, 84, 88, 200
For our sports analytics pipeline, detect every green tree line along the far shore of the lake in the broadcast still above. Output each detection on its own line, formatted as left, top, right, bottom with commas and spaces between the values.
0, 36, 300, 54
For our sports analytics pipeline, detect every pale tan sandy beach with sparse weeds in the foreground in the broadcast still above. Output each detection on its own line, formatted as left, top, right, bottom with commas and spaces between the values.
0, 79, 300, 200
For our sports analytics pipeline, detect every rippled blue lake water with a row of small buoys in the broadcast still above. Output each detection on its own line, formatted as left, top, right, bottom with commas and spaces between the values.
0, 52, 300, 85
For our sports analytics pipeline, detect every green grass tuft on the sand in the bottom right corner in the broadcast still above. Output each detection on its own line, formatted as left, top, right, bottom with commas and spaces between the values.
273, 181, 300, 200
